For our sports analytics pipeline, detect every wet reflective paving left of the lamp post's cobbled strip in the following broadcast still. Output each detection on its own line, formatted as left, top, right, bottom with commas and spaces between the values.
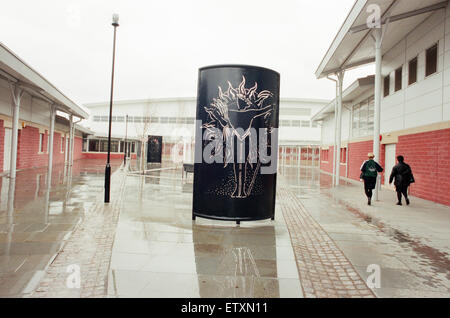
0, 160, 121, 297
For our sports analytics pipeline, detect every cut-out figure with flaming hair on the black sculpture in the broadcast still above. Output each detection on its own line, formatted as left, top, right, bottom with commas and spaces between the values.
203, 77, 273, 198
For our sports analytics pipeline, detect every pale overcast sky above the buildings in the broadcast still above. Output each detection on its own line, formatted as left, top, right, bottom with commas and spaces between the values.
0, 0, 373, 103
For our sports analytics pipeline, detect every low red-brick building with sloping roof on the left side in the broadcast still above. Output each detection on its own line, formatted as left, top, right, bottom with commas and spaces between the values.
0, 44, 92, 178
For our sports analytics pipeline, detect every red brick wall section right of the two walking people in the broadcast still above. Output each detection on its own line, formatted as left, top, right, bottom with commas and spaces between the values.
396, 129, 450, 205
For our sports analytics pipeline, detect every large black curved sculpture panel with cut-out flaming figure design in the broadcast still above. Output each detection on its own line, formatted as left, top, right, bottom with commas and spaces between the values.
192, 65, 280, 223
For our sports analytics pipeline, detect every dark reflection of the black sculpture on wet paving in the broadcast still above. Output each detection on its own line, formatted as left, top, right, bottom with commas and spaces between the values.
192, 225, 280, 298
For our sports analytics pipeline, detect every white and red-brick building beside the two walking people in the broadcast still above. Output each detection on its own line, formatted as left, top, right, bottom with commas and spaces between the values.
313, 0, 450, 205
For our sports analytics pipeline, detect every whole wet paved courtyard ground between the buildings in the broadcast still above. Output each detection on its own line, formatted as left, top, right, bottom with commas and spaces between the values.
0, 160, 450, 297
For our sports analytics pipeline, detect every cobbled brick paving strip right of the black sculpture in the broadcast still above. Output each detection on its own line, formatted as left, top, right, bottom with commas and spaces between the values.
278, 188, 375, 298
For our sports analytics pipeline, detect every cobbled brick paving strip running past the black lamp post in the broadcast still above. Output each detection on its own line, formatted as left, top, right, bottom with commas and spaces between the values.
27, 169, 126, 298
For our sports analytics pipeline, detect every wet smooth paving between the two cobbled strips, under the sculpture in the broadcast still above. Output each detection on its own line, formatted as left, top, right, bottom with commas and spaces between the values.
108, 169, 302, 297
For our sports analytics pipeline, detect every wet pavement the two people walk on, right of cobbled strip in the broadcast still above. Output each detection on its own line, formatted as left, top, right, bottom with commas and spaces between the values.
280, 169, 450, 297
